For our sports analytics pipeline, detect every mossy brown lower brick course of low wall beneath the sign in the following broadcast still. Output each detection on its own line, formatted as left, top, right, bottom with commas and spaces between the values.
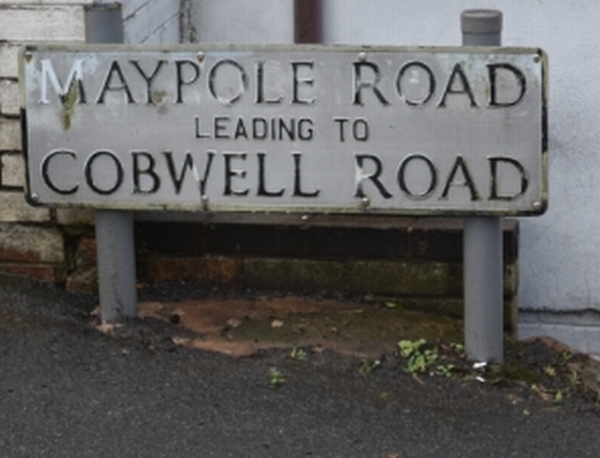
140, 255, 517, 330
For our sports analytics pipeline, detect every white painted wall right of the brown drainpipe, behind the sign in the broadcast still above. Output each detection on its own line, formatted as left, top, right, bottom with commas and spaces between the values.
323, 0, 600, 357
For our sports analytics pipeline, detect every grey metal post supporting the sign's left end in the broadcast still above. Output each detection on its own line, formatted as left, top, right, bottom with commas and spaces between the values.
85, 3, 137, 322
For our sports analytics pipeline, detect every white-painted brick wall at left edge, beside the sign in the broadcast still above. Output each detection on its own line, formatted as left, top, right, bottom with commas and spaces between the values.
0, 0, 91, 283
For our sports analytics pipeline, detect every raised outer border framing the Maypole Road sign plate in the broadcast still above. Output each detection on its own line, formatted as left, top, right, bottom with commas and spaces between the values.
19, 43, 548, 217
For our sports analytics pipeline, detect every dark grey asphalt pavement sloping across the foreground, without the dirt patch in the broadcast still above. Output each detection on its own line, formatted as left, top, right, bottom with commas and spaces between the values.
0, 276, 600, 458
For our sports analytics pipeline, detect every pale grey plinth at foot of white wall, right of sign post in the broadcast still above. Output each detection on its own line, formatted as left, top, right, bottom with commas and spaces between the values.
517, 310, 600, 360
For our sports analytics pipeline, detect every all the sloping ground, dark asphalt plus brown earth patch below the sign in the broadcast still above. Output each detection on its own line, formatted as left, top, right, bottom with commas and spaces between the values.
0, 276, 600, 458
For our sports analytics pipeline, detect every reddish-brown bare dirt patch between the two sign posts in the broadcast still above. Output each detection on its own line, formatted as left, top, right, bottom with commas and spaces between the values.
139, 295, 462, 357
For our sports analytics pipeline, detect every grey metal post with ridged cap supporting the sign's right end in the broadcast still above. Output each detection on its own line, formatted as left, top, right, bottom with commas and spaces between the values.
461, 10, 504, 362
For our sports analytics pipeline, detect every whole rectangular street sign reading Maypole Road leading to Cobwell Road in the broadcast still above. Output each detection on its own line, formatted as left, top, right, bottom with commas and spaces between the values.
20, 45, 547, 216
